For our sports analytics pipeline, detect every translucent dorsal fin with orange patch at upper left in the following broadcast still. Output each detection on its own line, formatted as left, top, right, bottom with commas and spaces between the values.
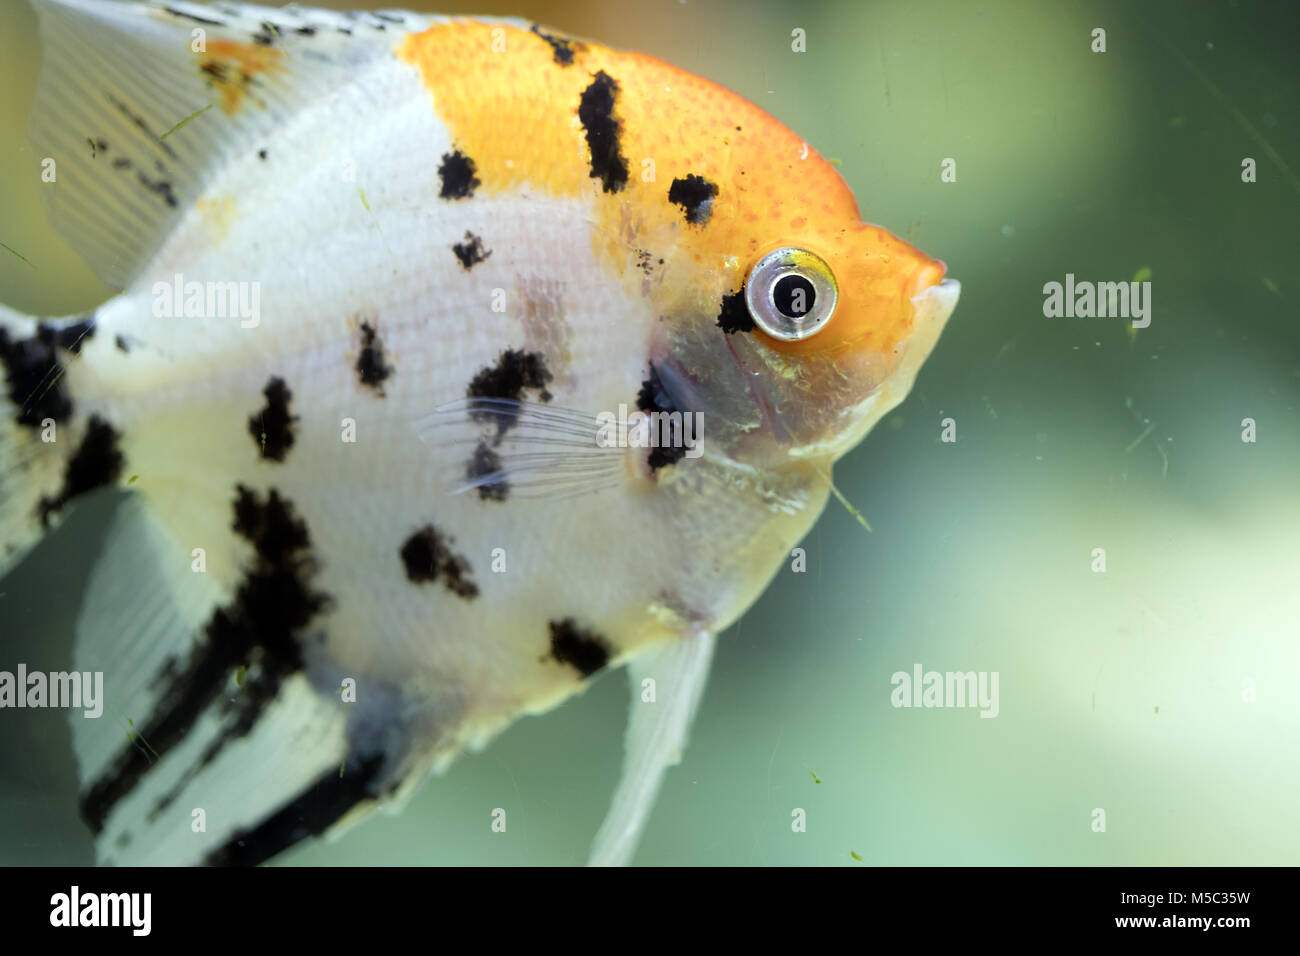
30, 0, 430, 289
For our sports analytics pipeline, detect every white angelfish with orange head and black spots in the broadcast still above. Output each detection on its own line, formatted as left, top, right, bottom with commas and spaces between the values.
0, 0, 959, 865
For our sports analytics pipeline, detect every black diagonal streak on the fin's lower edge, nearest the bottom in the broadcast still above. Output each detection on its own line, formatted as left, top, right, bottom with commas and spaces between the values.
203, 753, 385, 866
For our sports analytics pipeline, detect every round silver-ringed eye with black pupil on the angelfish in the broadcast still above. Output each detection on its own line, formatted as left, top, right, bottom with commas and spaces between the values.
745, 246, 839, 342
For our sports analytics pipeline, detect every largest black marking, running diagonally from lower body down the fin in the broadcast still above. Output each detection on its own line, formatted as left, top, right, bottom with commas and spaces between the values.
81, 485, 330, 834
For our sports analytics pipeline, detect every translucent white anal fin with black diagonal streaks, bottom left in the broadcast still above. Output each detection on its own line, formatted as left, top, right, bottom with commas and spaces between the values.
70, 496, 387, 865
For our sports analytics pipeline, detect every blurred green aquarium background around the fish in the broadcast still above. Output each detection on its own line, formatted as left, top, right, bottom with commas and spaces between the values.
0, 0, 1300, 866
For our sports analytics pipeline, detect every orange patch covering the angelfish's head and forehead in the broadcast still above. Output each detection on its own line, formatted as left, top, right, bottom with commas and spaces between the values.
397, 21, 946, 468
